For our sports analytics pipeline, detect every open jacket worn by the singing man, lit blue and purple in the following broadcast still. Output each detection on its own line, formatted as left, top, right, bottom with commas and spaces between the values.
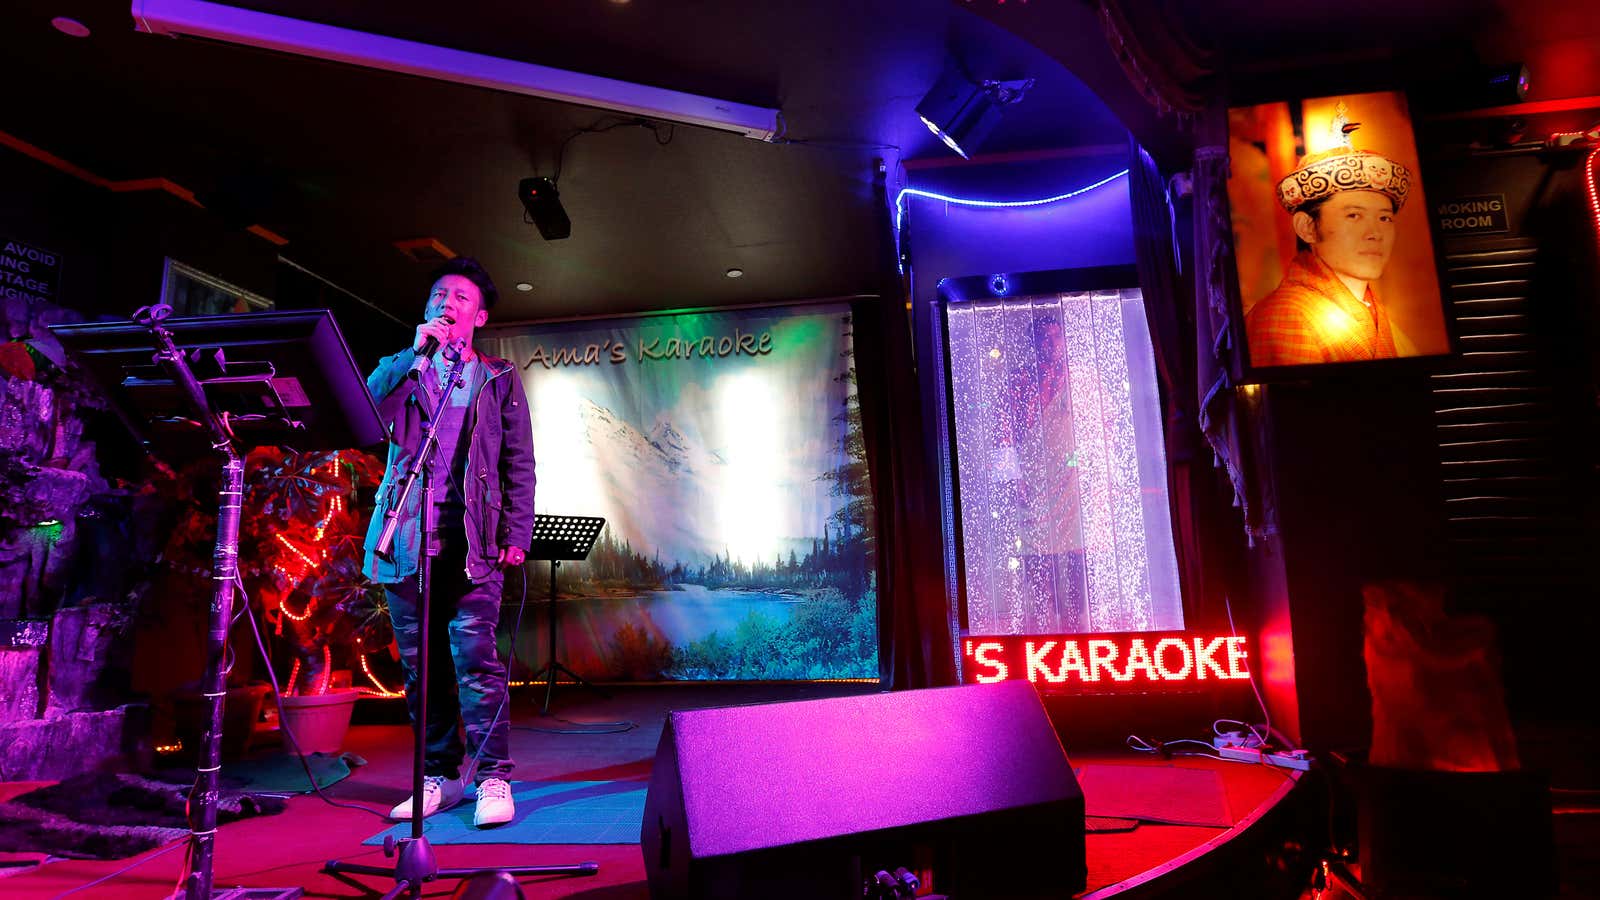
362, 342, 534, 583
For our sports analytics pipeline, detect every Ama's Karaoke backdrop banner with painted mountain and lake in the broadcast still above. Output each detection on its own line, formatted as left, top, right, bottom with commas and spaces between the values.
480, 304, 878, 681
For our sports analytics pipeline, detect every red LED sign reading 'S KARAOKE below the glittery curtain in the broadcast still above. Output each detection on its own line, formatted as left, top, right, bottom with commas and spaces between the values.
962, 631, 1250, 693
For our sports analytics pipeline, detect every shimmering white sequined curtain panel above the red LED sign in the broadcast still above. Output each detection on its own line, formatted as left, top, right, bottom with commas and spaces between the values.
947, 290, 1182, 634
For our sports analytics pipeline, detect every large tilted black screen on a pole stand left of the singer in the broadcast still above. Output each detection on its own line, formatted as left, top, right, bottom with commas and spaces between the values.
50, 304, 384, 900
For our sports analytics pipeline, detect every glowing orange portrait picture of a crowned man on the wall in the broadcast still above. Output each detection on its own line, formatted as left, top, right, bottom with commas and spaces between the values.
1227, 91, 1451, 373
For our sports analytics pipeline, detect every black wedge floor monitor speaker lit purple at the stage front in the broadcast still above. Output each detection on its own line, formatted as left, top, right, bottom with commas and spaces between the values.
640, 681, 1086, 900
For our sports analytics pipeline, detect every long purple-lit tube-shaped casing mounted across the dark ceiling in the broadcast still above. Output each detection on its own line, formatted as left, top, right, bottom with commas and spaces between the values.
131, 0, 782, 141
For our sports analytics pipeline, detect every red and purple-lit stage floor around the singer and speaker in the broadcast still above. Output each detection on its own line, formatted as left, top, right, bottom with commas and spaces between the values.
0, 684, 1291, 900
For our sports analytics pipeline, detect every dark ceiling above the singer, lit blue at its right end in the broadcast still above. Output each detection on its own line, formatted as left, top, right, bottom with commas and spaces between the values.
0, 0, 1125, 319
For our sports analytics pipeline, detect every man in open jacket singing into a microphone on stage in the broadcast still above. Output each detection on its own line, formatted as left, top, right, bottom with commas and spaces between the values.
365, 256, 534, 828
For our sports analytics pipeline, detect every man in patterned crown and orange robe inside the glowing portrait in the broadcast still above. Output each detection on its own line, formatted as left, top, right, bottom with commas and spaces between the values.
1245, 102, 1411, 367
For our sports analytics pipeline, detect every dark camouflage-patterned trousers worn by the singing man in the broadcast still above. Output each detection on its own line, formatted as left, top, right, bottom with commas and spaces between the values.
384, 532, 515, 781
